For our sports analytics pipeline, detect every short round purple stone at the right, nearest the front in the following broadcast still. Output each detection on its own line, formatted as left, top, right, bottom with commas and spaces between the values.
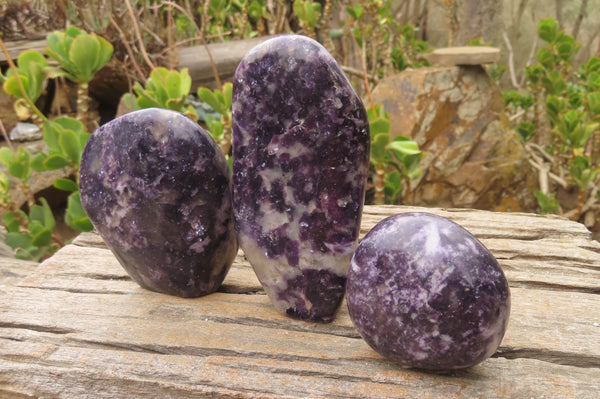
346, 213, 510, 370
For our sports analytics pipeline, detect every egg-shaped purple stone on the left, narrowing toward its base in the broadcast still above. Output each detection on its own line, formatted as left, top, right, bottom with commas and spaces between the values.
80, 108, 238, 297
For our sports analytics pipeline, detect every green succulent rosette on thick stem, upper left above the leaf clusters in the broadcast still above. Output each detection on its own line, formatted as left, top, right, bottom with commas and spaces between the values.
45, 26, 113, 124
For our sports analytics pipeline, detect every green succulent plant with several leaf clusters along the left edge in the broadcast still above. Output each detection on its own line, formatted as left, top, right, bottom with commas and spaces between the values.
0, 28, 107, 261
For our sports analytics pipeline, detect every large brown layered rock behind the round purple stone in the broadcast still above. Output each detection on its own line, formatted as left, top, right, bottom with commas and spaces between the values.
373, 65, 537, 211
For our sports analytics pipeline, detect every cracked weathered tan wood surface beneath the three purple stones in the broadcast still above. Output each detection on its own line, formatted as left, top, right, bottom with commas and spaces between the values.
0, 206, 600, 398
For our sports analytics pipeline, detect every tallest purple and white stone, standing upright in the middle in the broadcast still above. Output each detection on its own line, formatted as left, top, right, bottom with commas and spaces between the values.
233, 35, 370, 322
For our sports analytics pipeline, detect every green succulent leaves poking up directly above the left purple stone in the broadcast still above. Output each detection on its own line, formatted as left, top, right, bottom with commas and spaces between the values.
124, 67, 198, 121
